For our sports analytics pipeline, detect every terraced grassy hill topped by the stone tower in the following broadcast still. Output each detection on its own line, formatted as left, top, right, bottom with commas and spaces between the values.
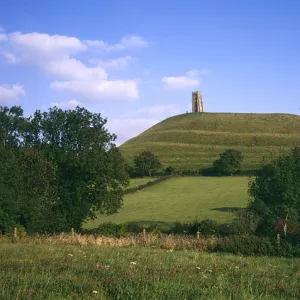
120, 113, 300, 170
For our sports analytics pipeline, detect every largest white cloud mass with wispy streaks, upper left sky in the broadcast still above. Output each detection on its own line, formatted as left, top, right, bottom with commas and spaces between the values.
3, 32, 148, 101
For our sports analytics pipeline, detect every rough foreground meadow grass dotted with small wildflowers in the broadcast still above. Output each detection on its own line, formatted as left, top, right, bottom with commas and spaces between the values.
0, 244, 300, 300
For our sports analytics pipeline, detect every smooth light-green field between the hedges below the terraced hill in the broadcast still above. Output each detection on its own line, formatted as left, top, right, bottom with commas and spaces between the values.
85, 177, 249, 228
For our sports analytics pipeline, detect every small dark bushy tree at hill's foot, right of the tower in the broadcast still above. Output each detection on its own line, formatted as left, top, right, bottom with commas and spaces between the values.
213, 149, 243, 175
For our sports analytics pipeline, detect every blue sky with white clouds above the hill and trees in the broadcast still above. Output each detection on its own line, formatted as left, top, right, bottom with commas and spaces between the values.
0, 0, 300, 144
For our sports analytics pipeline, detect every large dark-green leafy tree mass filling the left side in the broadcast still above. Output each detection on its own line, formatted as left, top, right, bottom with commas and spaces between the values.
0, 107, 128, 232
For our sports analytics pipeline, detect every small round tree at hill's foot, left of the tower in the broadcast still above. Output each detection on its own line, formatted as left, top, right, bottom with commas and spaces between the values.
134, 151, 162, 176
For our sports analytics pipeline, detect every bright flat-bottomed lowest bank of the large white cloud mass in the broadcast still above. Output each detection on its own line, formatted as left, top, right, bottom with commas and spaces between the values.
51, 80, 139, 100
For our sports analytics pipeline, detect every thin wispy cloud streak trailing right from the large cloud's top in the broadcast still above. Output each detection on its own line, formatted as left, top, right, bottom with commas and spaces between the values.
84, 35, 149, 52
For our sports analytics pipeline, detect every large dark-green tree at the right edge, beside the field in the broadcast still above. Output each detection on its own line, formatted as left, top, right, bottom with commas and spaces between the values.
248, 155, 300, 236
